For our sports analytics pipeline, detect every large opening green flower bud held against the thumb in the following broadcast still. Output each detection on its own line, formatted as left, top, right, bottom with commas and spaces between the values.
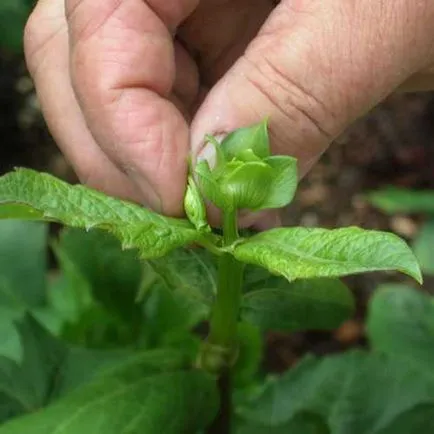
195, 122, 297, 211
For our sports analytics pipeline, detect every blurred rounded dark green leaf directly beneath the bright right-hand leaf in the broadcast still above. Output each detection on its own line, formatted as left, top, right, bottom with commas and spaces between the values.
241, 278, 355, 331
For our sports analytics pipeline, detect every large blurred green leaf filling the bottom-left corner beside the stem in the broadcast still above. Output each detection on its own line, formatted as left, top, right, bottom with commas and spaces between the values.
0, 351, 218, 434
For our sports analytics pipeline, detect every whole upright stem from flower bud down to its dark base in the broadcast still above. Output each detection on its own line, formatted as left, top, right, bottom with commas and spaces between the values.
207, 211, 244, 434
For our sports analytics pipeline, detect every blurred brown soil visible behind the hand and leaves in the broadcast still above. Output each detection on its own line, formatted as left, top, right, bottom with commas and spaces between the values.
0, 53, 434, 371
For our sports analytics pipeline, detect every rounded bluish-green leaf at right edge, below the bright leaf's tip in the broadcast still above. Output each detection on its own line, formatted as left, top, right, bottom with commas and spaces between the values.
367, 285, 434, 372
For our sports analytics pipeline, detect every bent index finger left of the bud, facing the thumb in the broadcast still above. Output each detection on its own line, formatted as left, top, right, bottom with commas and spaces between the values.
65, 0, 197, 214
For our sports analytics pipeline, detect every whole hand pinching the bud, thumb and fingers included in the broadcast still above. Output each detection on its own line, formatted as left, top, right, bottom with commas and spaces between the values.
25, 0, 434, 216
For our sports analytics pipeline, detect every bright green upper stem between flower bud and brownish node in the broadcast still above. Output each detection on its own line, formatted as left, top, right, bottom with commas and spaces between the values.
209, 212, 244, 353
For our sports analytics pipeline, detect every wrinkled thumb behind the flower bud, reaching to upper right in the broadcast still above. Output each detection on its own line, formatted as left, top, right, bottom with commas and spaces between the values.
191, 0, 434, 174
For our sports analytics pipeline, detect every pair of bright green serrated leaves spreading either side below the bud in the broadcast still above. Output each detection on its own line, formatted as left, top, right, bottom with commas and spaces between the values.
0, 169, 421, 282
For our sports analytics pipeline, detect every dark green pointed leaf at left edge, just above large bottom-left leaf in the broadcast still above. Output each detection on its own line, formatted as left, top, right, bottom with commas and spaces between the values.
0, 315, 130, 422
